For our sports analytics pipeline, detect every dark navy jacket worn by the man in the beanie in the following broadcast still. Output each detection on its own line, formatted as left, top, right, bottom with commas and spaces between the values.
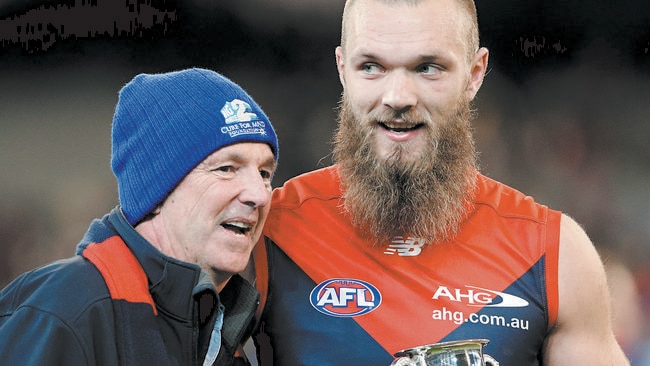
0, 209, 259, 365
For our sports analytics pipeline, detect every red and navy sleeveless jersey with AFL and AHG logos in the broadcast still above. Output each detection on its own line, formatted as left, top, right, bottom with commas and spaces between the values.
255, 166, 561, 365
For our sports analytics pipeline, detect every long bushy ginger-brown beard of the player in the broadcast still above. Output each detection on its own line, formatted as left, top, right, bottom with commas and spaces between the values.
333, 96, 477, 244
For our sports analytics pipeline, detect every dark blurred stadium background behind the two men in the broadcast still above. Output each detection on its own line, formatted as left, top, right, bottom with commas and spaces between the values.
0, 0, 650, 365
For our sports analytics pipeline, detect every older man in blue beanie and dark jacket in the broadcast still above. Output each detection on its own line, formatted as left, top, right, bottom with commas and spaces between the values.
0, 69, 278, 365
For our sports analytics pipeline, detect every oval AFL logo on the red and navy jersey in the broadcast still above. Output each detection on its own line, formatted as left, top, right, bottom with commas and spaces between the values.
309, 278, 381, 317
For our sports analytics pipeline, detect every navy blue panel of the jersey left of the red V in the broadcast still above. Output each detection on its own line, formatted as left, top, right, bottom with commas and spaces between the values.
264, 245, 393, 366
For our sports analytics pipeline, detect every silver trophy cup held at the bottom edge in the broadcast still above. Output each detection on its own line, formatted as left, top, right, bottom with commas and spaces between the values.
391, 339, 499, 366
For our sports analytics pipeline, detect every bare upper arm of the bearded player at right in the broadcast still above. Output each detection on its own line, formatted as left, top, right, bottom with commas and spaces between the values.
544, 215, 630, 366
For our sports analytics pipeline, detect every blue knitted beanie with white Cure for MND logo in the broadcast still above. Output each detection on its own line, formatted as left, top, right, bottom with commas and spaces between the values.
111, 68, 278, 225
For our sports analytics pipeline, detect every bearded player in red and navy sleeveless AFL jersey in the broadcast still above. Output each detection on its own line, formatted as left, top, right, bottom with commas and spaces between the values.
255, 0, 628, 366
